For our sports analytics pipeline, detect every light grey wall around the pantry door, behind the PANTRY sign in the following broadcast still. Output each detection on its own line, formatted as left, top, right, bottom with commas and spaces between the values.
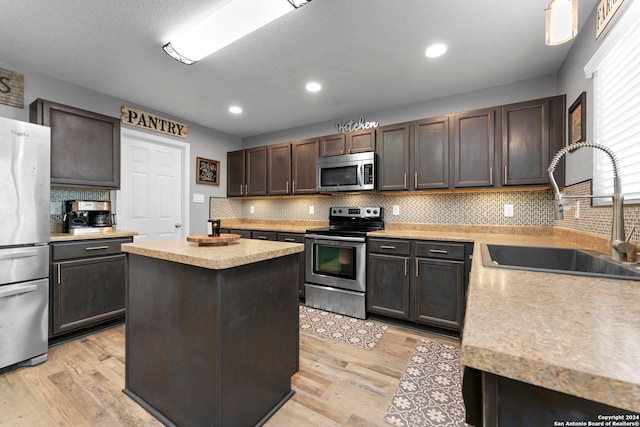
0, 61, 242, 234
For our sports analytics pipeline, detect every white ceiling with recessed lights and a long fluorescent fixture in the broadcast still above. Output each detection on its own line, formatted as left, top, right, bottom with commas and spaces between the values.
0, 0, 597, 137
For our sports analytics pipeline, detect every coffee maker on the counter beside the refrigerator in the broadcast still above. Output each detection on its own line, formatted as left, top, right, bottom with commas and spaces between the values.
62, 200, 116, 234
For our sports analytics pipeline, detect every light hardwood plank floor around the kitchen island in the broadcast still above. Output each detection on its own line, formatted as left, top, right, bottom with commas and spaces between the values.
0, 325, 457, 427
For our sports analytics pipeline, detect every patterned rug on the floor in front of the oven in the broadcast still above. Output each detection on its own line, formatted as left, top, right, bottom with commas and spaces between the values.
300, 305, 387, 350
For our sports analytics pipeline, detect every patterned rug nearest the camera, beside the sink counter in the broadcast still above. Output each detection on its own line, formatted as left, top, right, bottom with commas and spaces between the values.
384, 340, 466, 427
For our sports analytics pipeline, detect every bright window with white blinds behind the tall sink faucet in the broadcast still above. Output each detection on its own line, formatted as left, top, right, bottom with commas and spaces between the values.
584, 1, 640, 205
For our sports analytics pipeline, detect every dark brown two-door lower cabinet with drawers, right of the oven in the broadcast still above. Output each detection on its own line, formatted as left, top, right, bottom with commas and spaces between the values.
367, 239, 473, 333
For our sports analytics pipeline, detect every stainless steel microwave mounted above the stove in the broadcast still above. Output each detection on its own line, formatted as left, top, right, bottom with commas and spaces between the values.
316, 152, 376, 192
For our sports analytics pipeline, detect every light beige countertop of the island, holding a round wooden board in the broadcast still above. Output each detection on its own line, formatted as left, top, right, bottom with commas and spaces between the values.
122, 239, 304, 270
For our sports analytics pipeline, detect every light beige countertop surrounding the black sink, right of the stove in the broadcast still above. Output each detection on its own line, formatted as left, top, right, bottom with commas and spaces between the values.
368, 230, 640, 412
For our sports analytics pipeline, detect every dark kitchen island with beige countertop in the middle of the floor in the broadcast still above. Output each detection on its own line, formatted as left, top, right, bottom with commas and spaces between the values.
122, 239, 304, 426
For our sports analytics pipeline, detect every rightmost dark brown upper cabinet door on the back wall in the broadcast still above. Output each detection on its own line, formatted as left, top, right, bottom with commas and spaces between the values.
500, 99, 551, 185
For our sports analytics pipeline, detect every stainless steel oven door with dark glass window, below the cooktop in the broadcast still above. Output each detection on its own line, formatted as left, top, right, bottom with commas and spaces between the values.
305, 234, 367, 292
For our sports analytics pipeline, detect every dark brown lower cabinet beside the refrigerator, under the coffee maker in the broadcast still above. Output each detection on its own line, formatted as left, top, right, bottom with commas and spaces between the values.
49, 238, 133, 341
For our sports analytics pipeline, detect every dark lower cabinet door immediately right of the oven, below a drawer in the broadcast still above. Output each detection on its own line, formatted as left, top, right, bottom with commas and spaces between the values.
367, 254, 410, 319
